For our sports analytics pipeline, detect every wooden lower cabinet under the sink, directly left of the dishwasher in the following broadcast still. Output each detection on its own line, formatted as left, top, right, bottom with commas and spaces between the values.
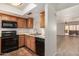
25, 35, 35, 52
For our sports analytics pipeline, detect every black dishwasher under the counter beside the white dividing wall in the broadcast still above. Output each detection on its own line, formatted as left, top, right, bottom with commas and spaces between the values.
36, 37, 45, 56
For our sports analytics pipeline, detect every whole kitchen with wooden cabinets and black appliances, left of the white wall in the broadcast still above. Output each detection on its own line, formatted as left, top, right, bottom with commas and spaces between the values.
0, 3, 45, 56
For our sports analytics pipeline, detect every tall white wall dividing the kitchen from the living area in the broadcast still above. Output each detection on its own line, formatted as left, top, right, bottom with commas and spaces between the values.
45, 4, 57, 56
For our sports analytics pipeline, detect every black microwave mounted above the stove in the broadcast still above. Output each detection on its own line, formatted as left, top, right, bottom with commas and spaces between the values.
2, 21, 17, 28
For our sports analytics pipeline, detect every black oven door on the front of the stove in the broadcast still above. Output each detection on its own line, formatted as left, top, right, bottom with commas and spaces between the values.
1, 38, 18, 53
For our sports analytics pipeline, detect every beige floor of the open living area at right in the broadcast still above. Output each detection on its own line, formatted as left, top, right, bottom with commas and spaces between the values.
56, 36, 79, 56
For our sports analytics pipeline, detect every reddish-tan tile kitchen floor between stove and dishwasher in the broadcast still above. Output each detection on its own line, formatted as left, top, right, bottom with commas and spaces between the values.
2, 47, 36, 56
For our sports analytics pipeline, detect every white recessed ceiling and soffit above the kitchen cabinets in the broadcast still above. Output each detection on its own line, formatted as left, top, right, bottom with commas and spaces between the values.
0, 3, 37, 18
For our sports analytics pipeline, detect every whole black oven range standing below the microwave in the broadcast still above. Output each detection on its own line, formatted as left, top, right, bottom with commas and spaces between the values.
1, 31, 18, 53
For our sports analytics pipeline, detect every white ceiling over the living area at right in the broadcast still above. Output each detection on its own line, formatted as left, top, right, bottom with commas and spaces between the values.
56, 3, 79, 23
